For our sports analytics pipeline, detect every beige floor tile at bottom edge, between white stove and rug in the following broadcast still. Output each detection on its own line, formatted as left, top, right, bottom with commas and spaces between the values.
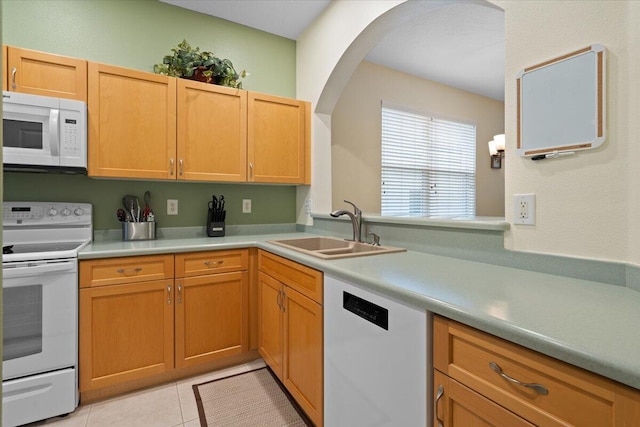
87, 383, 182, 427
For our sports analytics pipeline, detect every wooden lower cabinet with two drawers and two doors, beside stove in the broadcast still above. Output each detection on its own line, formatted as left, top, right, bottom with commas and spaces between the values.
79, 249, 249, 392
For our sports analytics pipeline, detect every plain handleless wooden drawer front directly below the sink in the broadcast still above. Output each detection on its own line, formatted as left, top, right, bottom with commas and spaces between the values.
258, 251, 322, 304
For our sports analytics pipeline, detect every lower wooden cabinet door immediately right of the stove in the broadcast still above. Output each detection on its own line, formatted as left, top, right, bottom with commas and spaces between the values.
79, 279, 173, 391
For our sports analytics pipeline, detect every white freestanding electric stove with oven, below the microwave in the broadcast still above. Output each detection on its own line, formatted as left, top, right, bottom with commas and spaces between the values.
2, 202, 93, 427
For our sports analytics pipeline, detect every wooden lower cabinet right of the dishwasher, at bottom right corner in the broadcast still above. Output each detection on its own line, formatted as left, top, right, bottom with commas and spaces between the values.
433, 316, 640, 427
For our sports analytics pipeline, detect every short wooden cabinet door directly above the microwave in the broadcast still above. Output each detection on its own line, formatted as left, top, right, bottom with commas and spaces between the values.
3, 46, 87, 102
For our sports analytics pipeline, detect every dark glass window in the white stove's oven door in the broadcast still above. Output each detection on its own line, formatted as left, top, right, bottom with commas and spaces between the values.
2, 285, 42, 361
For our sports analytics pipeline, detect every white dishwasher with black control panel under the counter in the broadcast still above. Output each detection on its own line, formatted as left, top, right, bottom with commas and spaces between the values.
324, 275, 433, 427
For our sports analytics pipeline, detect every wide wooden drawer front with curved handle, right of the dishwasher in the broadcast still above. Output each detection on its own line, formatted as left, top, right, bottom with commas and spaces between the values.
433, 317, 618, 426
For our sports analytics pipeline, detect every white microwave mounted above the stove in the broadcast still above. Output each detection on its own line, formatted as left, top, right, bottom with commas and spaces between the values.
2, 91, 87, 173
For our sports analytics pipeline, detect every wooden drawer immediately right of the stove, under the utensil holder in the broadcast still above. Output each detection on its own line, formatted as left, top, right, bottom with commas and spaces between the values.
80, 255, 173, 288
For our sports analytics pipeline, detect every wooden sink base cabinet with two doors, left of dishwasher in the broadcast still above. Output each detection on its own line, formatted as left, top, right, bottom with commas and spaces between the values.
258, 251, 323, 426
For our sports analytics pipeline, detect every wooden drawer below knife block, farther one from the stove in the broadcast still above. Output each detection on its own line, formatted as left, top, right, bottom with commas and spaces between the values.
176, 249, 249, 277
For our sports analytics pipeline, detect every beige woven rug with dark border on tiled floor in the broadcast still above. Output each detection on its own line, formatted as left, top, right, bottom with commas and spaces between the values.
193, 368, 312, 427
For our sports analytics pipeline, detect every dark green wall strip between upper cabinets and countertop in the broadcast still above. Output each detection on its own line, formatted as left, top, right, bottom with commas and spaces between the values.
4, 172, 296, 230
